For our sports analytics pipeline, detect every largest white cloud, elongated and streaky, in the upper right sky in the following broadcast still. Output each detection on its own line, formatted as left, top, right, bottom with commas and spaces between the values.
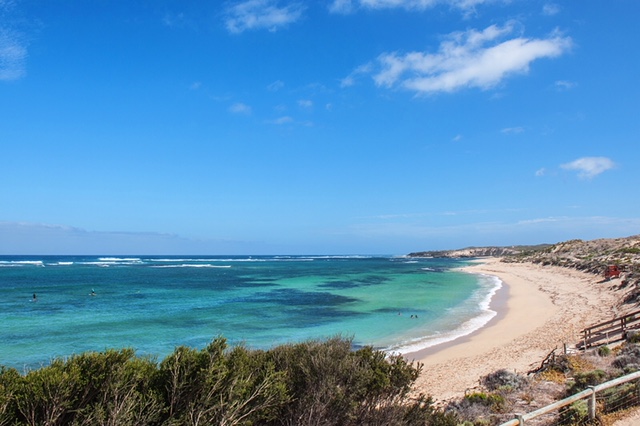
360, 22, 572, 94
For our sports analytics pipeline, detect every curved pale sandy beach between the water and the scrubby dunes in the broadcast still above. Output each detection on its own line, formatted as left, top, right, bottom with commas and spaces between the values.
406, 258, 619, 401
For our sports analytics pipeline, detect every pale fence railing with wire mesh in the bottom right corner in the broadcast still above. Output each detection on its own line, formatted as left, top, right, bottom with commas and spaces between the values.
500, 371, 640, 426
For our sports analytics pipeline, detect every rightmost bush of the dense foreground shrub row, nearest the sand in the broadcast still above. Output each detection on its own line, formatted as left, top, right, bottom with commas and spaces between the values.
260, 337, 434, 425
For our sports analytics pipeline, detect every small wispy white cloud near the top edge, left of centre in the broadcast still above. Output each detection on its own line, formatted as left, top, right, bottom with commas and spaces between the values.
225, 0, 304, 34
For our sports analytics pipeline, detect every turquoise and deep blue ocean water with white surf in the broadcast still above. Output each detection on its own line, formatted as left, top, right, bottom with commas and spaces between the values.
0, 256, 501, 368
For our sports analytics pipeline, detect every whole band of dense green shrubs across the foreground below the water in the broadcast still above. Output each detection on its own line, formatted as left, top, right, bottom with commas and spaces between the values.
0, 338, 458, 426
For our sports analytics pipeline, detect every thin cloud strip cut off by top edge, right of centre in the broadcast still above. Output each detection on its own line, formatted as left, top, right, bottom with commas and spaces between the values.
329, 0, 495, 14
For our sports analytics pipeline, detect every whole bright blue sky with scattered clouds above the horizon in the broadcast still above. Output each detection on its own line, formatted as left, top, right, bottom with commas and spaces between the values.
0, 0, 640, 254
